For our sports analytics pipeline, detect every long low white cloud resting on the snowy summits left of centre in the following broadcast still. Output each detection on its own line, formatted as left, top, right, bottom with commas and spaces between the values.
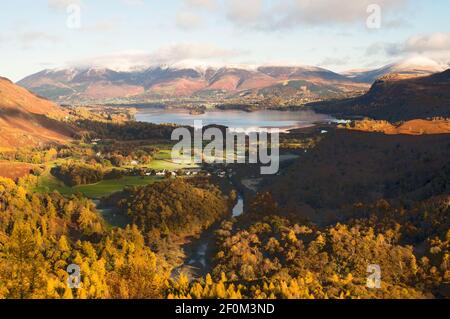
68, 44, 242, 71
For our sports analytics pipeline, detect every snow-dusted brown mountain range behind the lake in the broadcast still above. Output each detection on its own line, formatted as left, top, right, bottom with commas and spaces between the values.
18, 56, 444, 103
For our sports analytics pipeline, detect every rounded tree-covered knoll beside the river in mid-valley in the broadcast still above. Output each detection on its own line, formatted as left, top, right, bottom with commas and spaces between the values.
109, 179, 229, 240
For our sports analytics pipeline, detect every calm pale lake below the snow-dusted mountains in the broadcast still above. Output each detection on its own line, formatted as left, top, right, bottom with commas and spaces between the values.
136, 109, 336, 130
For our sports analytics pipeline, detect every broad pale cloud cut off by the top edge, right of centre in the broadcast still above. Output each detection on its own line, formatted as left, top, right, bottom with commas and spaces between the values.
177, 0, 411, 31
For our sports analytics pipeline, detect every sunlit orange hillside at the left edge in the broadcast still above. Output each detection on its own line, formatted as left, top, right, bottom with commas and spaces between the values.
0, 77, 75, 148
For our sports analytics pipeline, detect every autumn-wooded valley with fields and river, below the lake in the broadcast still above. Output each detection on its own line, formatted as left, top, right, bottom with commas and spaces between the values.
0, 114, 450, 299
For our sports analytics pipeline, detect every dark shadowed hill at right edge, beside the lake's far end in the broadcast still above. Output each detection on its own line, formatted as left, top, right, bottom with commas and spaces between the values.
310, 70, 450, 122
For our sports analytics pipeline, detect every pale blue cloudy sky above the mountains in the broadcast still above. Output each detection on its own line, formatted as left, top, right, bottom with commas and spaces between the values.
0, 0, 450, 81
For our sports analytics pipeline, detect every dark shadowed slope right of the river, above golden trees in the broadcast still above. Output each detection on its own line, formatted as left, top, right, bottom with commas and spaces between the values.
265, 130, 450, 222
